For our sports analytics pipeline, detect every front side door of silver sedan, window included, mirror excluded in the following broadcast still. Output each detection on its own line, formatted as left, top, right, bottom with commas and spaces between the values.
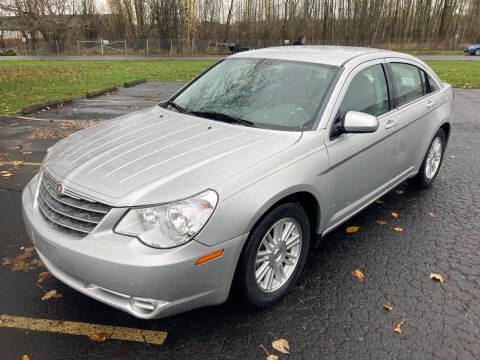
325, 59, 398, 232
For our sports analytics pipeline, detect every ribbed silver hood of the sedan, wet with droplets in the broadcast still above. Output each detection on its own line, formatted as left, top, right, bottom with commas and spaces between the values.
44, 106, 301, 206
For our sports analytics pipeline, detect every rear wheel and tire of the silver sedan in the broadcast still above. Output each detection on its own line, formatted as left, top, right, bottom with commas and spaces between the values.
412, 129, 447, 189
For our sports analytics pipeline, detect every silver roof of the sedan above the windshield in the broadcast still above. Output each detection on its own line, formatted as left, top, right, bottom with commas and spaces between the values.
229, 45, 404, 66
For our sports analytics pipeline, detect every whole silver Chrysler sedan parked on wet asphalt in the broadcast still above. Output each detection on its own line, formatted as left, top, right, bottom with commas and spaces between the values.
23, 46, 453, 319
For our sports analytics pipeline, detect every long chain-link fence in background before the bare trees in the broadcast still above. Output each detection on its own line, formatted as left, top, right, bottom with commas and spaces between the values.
0, 38, 480, 56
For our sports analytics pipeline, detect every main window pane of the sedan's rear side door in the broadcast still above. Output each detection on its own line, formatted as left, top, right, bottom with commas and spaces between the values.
390, 63, 424, 105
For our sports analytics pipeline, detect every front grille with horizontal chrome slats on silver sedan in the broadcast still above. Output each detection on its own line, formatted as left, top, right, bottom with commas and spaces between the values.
37, 171, 111, 237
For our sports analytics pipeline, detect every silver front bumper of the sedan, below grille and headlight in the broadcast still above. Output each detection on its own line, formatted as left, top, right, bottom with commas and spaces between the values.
22, 178, 248, 319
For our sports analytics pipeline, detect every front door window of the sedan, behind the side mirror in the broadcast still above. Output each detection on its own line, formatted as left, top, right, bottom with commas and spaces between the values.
330, 64, 390, 139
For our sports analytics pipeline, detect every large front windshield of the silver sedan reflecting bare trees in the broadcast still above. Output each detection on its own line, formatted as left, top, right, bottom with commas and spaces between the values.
173, 58, 338, 130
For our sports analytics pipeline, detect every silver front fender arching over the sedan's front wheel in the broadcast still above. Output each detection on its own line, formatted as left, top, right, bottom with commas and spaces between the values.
196, 130, 329, 246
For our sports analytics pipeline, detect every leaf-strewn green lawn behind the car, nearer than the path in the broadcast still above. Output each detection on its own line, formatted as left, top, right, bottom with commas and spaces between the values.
0, 60, 480, 115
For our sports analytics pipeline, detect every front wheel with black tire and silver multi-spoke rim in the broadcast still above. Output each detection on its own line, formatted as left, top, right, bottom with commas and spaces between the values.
238, 203, 310, 307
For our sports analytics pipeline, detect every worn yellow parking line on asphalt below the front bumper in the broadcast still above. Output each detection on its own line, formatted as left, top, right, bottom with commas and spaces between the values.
0, 314, 168, 345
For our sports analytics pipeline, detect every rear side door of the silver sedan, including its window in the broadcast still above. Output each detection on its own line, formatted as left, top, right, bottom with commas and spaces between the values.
388, 59, 443, 174
